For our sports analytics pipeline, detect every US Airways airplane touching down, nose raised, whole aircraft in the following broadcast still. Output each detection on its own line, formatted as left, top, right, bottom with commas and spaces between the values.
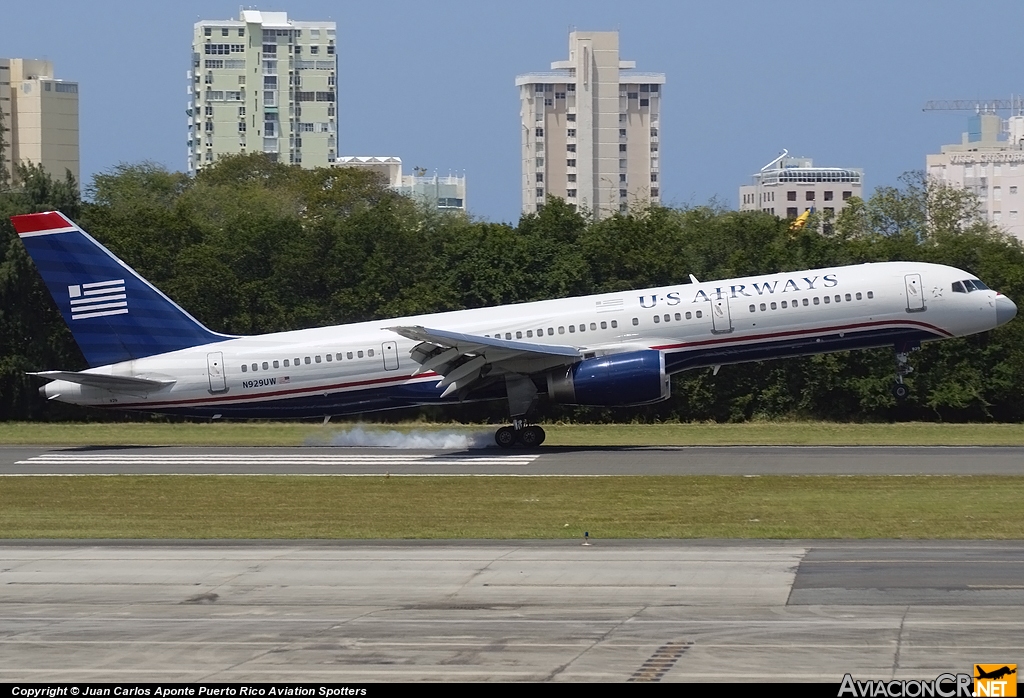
11, 211, 1017, 448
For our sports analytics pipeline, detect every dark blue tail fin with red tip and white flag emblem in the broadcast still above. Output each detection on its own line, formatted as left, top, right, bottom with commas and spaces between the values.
11, 211, 230, 366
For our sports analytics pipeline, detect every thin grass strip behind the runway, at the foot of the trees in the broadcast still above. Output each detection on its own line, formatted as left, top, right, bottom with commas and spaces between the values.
6, 422, 1024, 447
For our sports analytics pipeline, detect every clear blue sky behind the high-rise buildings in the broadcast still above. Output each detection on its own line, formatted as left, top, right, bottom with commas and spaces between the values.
8, 0, 1024, 221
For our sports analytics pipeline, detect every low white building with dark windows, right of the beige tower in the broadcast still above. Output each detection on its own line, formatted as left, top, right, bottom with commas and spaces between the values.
739, 150, 864, 218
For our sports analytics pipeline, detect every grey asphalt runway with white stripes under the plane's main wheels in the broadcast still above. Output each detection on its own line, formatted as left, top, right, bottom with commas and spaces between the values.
0, 446, 1024, 476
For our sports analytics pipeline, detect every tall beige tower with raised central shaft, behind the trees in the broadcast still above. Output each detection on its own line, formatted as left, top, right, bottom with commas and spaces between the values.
515, 32, 665, 219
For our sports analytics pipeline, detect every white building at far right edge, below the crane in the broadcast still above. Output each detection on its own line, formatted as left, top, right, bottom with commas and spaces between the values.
926, 114, 1024, 241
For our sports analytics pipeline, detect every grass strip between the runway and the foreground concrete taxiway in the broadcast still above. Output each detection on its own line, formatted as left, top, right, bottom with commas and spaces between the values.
0, 475, 1024, 539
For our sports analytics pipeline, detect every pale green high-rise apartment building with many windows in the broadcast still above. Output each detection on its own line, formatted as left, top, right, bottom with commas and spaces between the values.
187, 10, 338, 173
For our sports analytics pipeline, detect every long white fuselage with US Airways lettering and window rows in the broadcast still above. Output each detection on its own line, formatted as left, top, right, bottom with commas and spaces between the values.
43, 262, 999, 418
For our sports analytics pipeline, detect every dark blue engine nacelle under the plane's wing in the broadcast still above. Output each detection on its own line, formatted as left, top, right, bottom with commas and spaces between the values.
548, 349, 672, 407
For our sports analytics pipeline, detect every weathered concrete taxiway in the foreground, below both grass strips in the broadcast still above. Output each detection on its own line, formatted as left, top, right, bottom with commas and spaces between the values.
0, 540, 1024, 684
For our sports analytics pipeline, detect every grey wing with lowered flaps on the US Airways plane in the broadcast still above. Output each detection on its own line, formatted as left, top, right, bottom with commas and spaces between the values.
387, 325, 583, 397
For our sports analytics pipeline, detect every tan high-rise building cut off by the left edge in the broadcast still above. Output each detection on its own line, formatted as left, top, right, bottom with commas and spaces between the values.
0, 58, 79, 182
